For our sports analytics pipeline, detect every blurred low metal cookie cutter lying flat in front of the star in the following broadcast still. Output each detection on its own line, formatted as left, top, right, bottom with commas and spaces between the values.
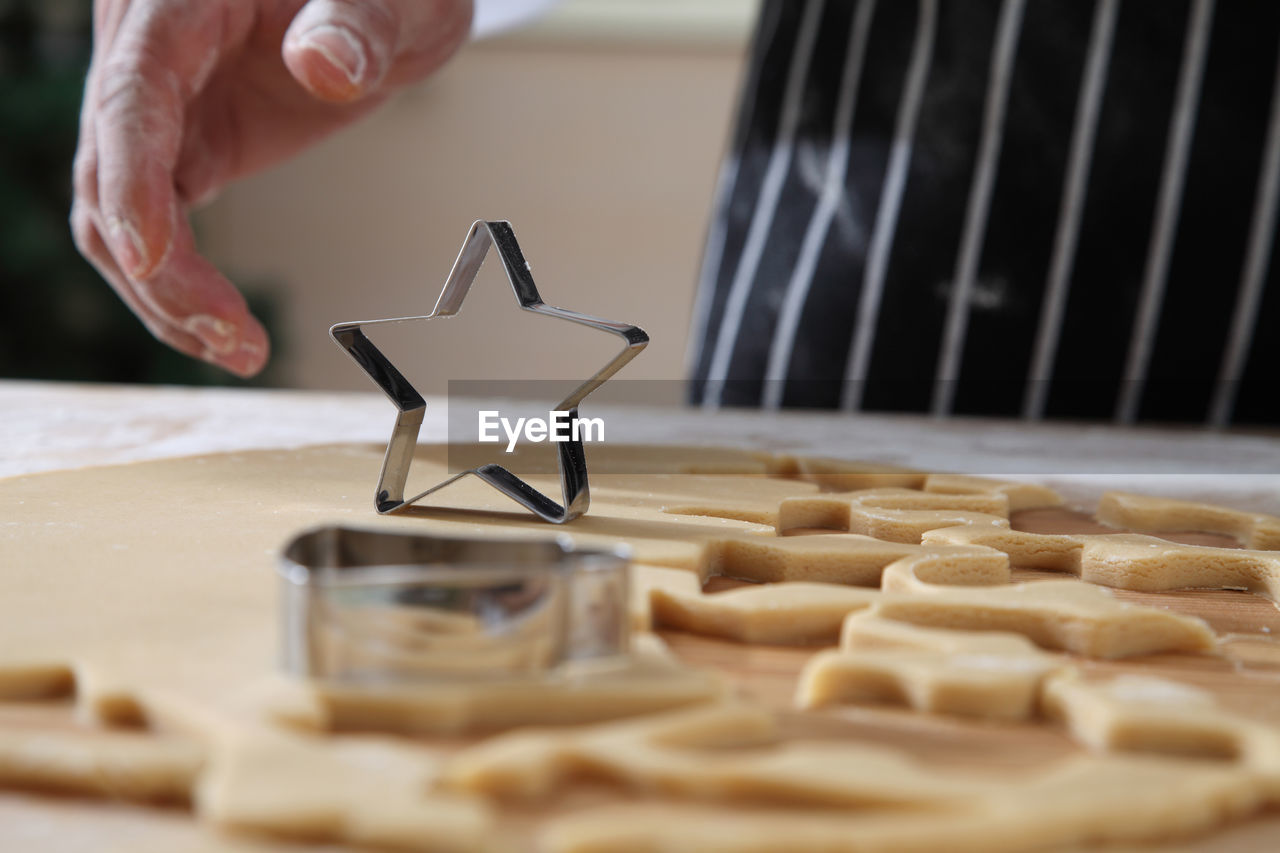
279, 526, 631, 683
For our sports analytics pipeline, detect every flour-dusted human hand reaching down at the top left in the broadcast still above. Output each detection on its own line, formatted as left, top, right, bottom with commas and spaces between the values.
72, 0, 471, 377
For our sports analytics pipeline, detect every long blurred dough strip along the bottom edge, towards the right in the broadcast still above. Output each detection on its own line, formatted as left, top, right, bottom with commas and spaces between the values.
539, 756, 1266, 853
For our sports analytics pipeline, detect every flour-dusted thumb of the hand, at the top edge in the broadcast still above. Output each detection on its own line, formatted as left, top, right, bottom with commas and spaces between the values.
283, 0, 471, 102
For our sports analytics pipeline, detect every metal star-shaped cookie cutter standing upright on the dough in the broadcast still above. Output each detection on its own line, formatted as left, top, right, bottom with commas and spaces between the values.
329, 219, 649, 524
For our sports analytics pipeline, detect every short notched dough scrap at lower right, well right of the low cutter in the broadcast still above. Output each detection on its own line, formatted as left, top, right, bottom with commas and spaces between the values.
796, 611, 1061, 720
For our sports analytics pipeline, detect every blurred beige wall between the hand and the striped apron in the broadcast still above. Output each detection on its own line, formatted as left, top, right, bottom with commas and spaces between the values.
197, 1, 754, 392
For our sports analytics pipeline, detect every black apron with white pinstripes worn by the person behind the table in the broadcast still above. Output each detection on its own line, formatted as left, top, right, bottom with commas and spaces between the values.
690, 0, 1280, 425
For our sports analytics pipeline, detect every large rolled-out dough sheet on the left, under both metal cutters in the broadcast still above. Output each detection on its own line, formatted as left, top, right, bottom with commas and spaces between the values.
0, 446, 768, 849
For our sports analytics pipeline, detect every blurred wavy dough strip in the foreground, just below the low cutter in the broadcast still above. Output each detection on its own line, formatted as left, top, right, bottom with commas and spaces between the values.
443, 704, 995, 809
